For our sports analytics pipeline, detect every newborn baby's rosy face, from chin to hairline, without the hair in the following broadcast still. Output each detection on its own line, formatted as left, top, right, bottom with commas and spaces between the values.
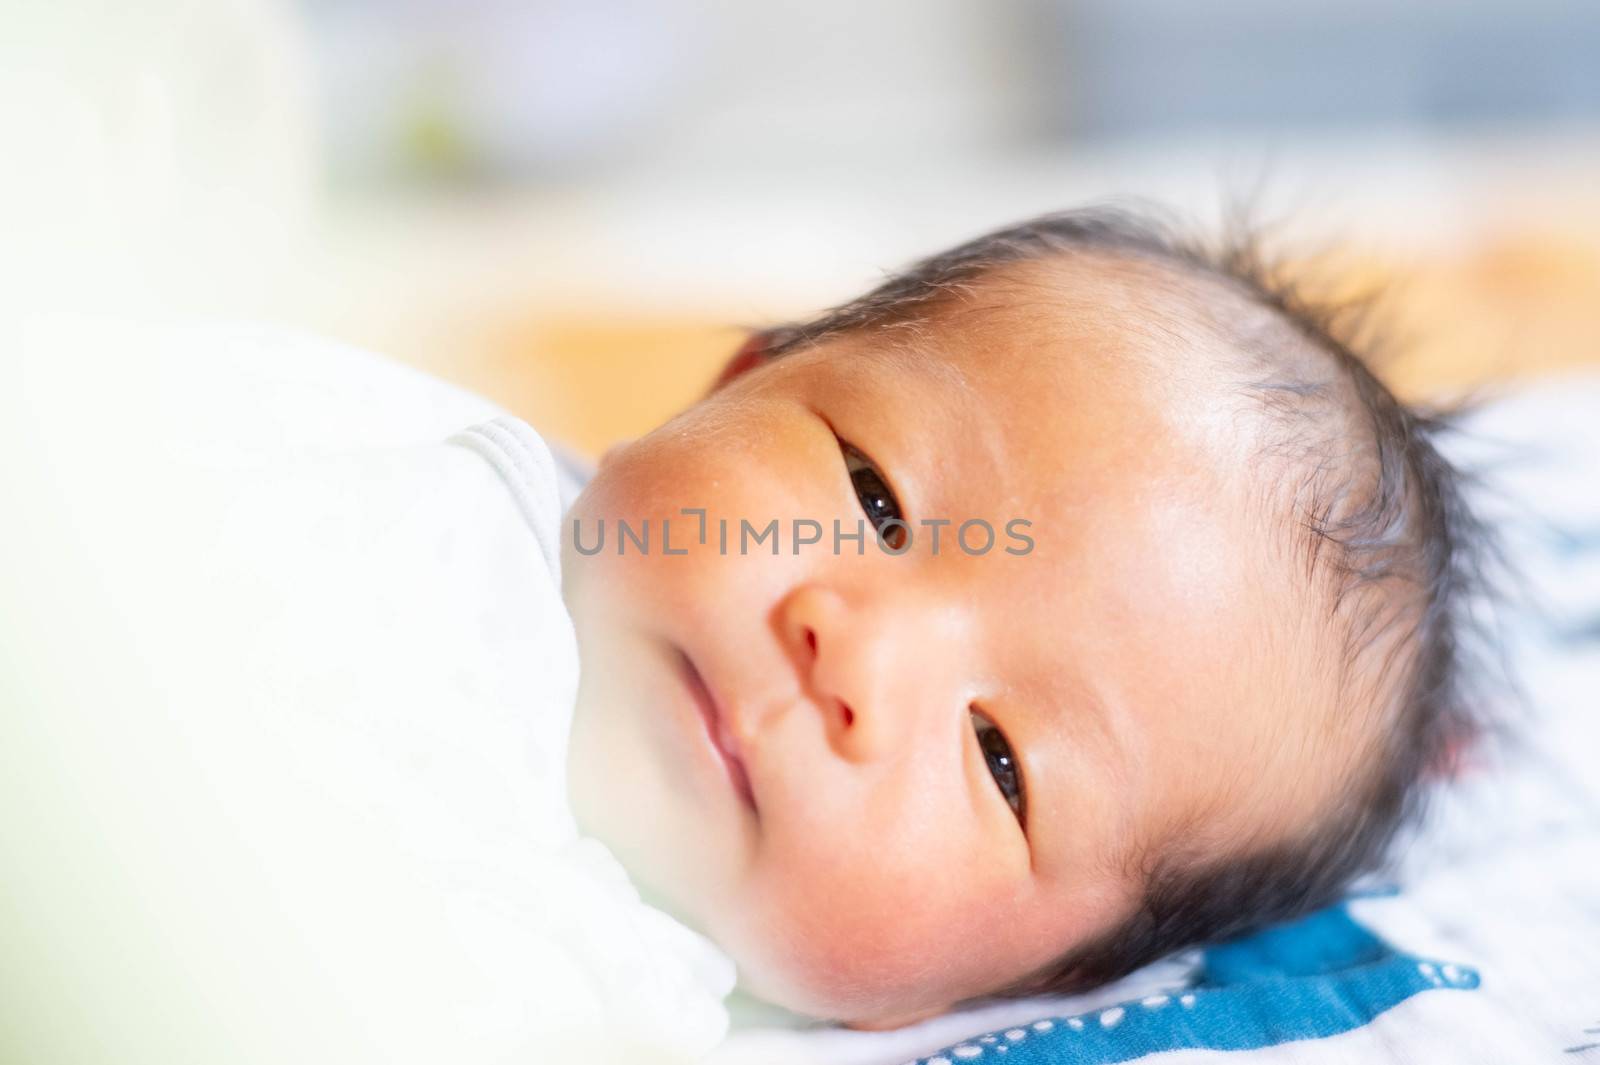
565, 260, 1330, 1023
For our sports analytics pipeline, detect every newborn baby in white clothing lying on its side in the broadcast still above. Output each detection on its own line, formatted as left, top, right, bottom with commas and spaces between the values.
0, 204, 1474, 1062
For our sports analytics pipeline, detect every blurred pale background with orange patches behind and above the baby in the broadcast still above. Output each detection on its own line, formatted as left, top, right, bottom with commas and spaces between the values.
9, 0, 1600, 453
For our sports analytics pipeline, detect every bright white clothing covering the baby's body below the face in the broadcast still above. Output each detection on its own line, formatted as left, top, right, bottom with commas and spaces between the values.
0, 321, 733, 1065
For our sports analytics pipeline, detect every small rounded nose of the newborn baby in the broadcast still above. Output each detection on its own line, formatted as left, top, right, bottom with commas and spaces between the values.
778, 584, 965, 761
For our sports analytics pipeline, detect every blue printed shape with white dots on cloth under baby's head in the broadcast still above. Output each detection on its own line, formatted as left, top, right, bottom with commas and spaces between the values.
917, 903, 1478, 1065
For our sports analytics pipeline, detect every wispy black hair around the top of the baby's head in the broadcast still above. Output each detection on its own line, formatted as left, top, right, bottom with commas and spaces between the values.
745, 208, 1491, 995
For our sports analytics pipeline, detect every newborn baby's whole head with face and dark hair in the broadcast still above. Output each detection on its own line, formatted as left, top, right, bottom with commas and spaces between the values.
565, 204, 1469, 1023
